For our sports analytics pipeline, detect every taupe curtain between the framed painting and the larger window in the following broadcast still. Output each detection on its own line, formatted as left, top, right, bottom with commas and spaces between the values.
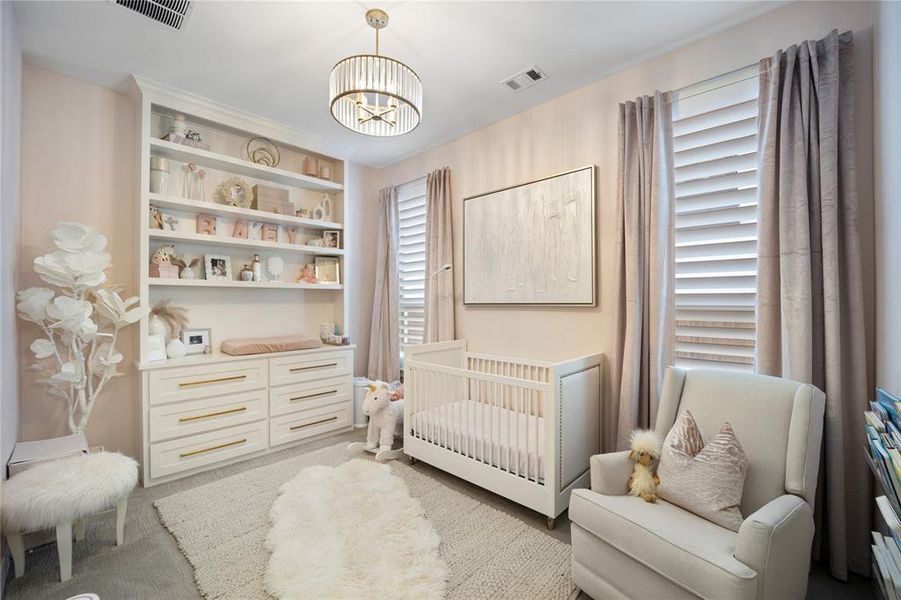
602, 92, 675, 450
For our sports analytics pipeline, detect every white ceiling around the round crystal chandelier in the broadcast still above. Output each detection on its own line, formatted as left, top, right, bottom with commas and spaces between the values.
16, 0, 784, 166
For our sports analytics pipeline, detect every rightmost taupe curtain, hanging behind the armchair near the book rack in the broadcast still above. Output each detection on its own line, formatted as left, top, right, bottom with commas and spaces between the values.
756, 31, 872, 579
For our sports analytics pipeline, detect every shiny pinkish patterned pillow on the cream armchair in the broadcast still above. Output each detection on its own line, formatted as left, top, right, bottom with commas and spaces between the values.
657, 410, 748, 531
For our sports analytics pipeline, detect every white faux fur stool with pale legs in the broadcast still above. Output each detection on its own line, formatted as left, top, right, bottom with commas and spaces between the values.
0, 452, 138, 581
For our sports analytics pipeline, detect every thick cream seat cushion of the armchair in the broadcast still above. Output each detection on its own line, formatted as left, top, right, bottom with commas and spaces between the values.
569, 489, 757, 599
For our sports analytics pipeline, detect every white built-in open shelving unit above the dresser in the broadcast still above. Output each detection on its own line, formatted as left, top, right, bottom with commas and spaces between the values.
133, 78, 348, 364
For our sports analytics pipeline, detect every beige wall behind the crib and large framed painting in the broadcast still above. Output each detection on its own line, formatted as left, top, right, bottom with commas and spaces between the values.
366, 2, 873, 396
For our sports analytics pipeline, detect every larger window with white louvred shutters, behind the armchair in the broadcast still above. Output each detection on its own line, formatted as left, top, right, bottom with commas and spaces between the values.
673, 65, 758, 371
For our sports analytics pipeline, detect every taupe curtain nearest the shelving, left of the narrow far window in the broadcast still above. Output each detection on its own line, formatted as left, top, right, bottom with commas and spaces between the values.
367, 187, 400, 381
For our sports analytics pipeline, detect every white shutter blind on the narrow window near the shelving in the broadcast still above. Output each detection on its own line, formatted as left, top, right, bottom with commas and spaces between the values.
397, 177, 426, 346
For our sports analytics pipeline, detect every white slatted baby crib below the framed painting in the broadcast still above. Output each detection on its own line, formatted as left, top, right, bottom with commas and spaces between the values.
404, 340, 601, 528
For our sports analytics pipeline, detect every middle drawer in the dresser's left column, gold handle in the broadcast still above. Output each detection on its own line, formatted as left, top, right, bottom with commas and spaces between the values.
150, 388, 269, 442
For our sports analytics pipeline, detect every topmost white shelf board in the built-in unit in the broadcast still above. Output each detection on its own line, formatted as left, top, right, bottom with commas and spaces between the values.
150, 138, 344, 192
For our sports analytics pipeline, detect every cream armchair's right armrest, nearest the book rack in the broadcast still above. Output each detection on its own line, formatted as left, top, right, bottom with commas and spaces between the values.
735, 494, 814, 599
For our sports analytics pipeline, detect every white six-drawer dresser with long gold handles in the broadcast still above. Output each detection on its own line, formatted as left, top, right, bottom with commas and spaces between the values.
141, 346, 353, 486
